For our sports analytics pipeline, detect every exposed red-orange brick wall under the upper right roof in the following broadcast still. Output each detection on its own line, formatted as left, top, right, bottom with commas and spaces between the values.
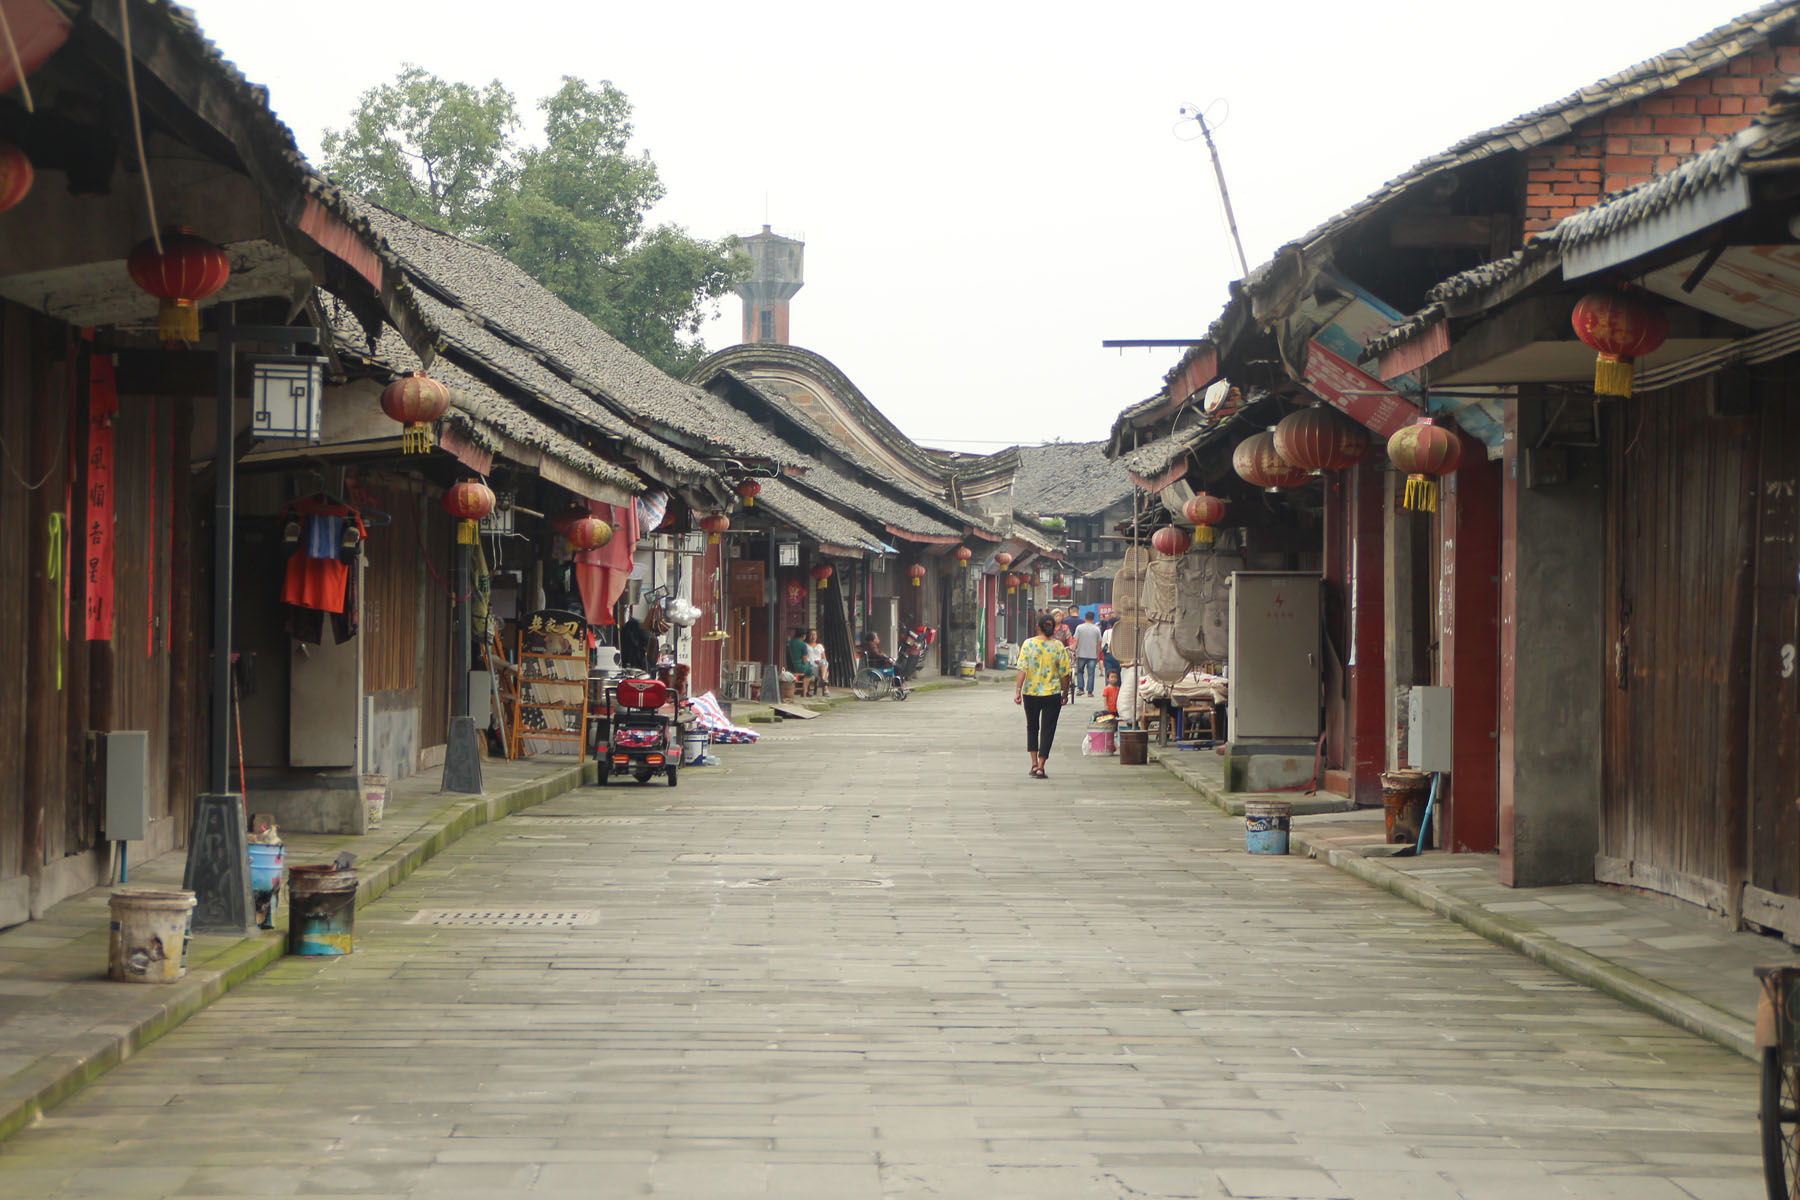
1523, 45, 1800, 236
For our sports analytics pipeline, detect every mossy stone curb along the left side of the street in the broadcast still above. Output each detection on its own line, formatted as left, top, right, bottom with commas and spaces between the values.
0, 763, 596, 1141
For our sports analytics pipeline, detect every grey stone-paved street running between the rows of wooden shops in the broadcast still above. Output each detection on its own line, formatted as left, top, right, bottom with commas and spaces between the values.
0, 685, 1762, 1200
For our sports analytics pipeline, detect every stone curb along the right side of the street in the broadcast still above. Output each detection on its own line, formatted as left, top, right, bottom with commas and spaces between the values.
1154, 744, 1762, 1060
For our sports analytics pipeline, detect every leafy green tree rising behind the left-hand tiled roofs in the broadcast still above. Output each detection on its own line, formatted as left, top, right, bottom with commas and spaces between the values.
324, 67, 749, 374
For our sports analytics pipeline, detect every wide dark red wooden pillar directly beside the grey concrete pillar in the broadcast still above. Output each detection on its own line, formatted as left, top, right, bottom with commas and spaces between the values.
1438, 437, 1501, 853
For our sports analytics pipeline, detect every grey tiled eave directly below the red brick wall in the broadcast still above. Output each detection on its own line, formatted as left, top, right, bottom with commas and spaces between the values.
1363, 79, 1800, 358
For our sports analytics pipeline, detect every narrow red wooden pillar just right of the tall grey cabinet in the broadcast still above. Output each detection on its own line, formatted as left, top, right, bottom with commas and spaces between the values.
1345, 462, 1388, 808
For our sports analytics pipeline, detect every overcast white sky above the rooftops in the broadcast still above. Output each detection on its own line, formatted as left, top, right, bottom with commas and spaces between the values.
187, 0, 1751, 450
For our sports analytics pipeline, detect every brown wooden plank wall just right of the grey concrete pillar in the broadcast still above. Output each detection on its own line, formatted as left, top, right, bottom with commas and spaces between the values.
1597, 380, 1757, 914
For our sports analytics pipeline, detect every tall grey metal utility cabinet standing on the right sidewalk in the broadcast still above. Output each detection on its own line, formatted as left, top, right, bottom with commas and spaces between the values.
1229, 570, 1325, 745
